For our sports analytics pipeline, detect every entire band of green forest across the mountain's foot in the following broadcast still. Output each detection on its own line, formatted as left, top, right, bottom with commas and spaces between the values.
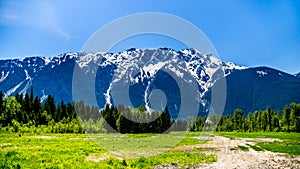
0, 89, 300, 133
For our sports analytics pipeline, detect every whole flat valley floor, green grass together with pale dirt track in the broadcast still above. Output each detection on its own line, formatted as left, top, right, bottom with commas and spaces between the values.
0, 133, 300, 169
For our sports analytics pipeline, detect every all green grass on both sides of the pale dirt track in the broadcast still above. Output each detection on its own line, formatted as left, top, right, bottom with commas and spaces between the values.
0, 132, 300, 169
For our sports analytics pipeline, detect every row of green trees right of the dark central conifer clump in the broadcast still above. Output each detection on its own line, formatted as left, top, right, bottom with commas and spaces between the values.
187, 103, 300, 133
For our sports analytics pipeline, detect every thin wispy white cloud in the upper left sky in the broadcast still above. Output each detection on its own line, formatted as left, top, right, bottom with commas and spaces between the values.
0, 0, 70, 39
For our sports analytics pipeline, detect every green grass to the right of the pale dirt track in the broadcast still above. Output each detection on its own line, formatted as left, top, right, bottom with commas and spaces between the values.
215, 132, 300, 155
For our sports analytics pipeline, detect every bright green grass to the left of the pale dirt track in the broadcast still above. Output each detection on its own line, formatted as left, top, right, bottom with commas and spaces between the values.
0, 133, 216, 168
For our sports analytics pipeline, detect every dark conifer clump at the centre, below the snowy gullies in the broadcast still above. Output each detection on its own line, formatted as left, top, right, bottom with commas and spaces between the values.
101, 105, 172, 134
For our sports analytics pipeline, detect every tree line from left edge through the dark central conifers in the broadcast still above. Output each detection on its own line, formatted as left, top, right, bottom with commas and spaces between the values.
0, 88, 171, 133
